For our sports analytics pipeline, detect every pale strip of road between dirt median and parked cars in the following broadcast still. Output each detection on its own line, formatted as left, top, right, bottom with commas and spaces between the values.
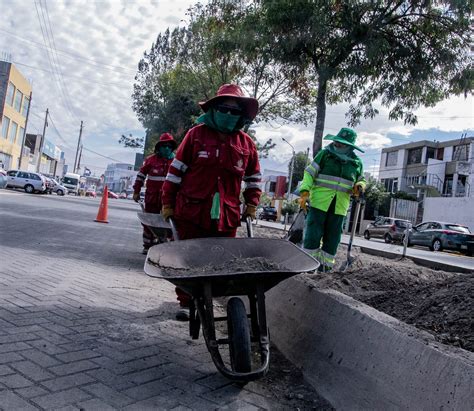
258, 220, 474, 270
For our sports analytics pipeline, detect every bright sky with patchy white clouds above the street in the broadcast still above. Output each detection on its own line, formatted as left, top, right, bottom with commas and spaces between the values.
0, 0, 474, 175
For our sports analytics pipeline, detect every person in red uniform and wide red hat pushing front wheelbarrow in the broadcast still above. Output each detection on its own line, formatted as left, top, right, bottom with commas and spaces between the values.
161, 84, 261, 320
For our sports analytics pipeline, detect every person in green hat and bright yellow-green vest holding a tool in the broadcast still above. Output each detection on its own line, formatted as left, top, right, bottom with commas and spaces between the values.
300, 128, 366, 272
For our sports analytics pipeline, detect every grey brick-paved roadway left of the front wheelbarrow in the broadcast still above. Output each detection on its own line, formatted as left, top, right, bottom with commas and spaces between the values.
0, 190, 327, 410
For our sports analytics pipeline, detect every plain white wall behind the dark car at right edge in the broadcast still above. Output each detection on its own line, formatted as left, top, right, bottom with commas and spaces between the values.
423, 197, 474, 232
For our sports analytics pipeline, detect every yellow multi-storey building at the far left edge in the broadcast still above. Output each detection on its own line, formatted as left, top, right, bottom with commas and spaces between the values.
0, 61, 31, 170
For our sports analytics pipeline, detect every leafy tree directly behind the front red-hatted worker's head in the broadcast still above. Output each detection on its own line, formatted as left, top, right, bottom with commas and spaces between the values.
132, 0, 314, 156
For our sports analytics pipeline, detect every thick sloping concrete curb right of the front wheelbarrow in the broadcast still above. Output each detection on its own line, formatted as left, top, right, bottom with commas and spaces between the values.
267, 275, 474, 410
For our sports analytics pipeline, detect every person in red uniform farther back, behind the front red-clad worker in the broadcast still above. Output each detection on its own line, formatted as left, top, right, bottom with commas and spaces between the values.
133, 133, 177, 254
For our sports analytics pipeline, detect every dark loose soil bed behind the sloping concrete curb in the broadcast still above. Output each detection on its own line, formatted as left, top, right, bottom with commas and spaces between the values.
239, 228, 474, 351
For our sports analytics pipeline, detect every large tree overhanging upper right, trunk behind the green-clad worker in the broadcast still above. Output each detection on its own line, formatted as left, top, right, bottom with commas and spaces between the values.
261, 0, 473, 153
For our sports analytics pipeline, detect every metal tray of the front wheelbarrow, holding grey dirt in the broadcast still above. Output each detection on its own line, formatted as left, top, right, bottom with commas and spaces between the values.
145, 238, 319, 297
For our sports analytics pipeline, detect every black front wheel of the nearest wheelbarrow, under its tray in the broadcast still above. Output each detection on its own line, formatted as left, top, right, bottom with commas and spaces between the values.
227, 297, 252, 372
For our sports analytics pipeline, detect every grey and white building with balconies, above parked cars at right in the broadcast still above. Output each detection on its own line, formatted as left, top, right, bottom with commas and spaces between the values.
379, 137, 474, 199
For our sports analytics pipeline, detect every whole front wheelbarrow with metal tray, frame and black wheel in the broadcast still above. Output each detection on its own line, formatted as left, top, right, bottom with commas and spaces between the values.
145, 219, 319, 382
